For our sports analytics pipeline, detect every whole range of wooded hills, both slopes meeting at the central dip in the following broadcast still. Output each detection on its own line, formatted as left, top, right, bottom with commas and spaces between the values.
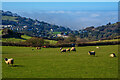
1, 11, 120, 41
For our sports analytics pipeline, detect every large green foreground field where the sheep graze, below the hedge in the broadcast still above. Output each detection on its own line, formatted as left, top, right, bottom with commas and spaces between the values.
2, 45, 118, 78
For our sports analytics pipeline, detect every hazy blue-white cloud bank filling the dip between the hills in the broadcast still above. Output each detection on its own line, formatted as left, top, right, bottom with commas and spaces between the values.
18, 10, 118, 30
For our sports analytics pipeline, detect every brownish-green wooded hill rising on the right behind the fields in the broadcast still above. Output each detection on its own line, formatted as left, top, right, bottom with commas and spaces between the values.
79, 22, 120, 40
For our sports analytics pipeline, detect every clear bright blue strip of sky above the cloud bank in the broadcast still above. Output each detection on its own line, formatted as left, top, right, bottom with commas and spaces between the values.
2, 2, 118, 11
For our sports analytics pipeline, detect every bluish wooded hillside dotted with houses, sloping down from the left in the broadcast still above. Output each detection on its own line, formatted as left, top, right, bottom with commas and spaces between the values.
1, 11, 71, 37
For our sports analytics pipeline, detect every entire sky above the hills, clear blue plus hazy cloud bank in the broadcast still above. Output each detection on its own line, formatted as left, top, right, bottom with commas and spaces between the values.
2, 0, 118, 30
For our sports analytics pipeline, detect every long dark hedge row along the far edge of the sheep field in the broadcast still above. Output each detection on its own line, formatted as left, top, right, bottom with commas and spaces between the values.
0, 41, 120, 48
